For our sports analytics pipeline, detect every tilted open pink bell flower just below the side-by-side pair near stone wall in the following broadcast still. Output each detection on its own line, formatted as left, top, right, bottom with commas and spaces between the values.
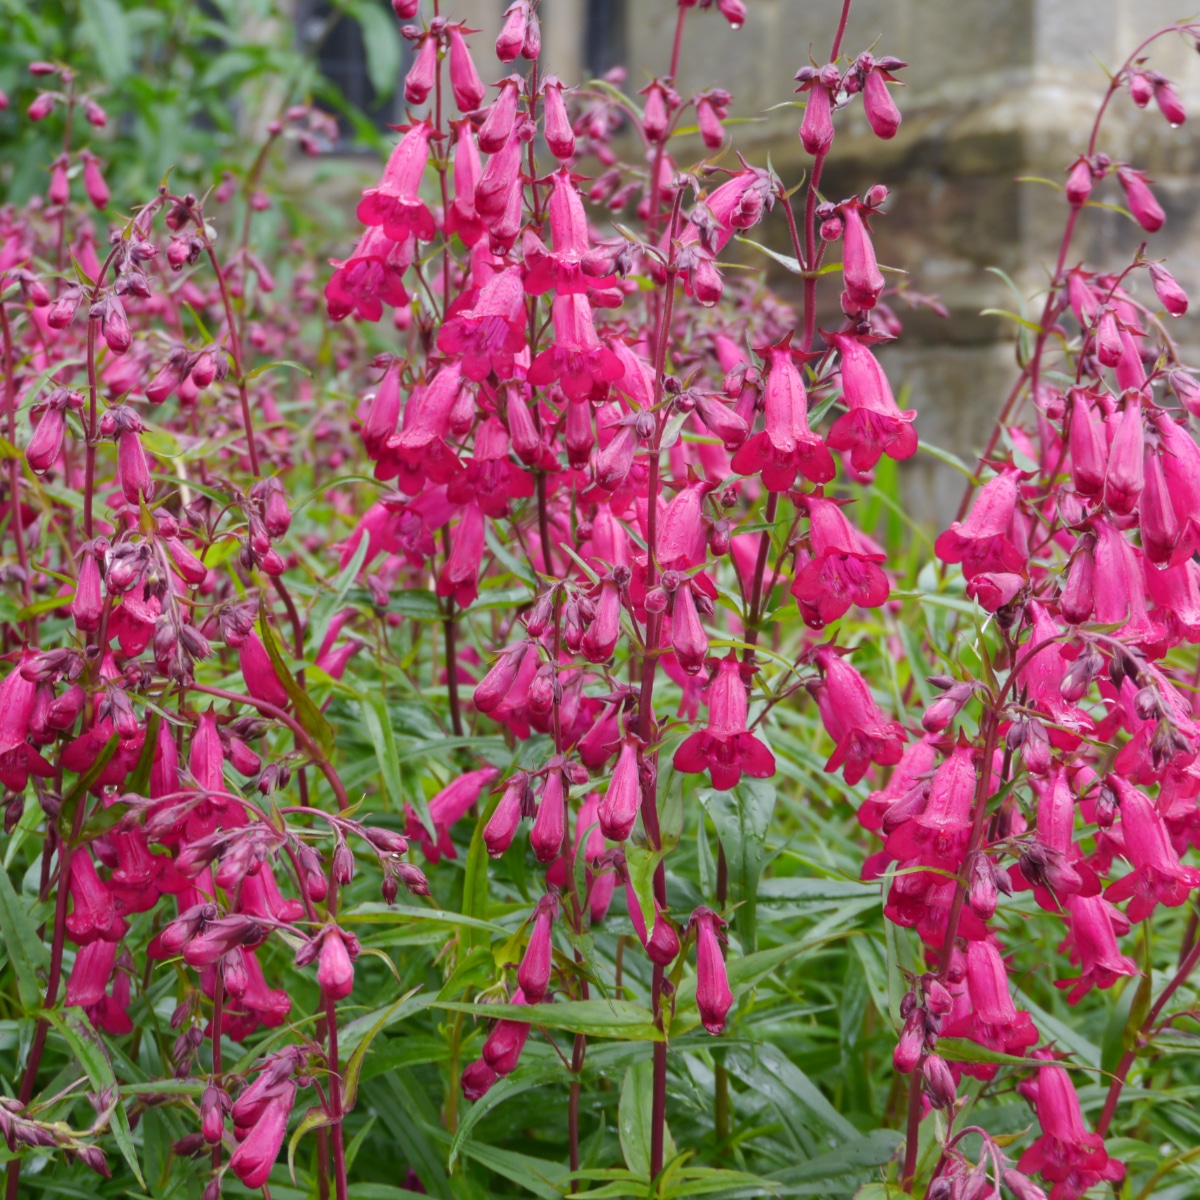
792, 494, 889, 629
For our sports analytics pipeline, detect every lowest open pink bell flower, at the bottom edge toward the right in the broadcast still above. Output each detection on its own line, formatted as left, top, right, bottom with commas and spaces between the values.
1018, 1066, 1124, 1200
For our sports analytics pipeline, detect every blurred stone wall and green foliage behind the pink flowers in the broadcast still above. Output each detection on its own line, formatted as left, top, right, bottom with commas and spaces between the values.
0, 0, 1200, 524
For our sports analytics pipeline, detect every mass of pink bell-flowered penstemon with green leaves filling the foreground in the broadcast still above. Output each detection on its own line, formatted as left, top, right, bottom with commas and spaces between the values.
0, 0, 1200, 1200
